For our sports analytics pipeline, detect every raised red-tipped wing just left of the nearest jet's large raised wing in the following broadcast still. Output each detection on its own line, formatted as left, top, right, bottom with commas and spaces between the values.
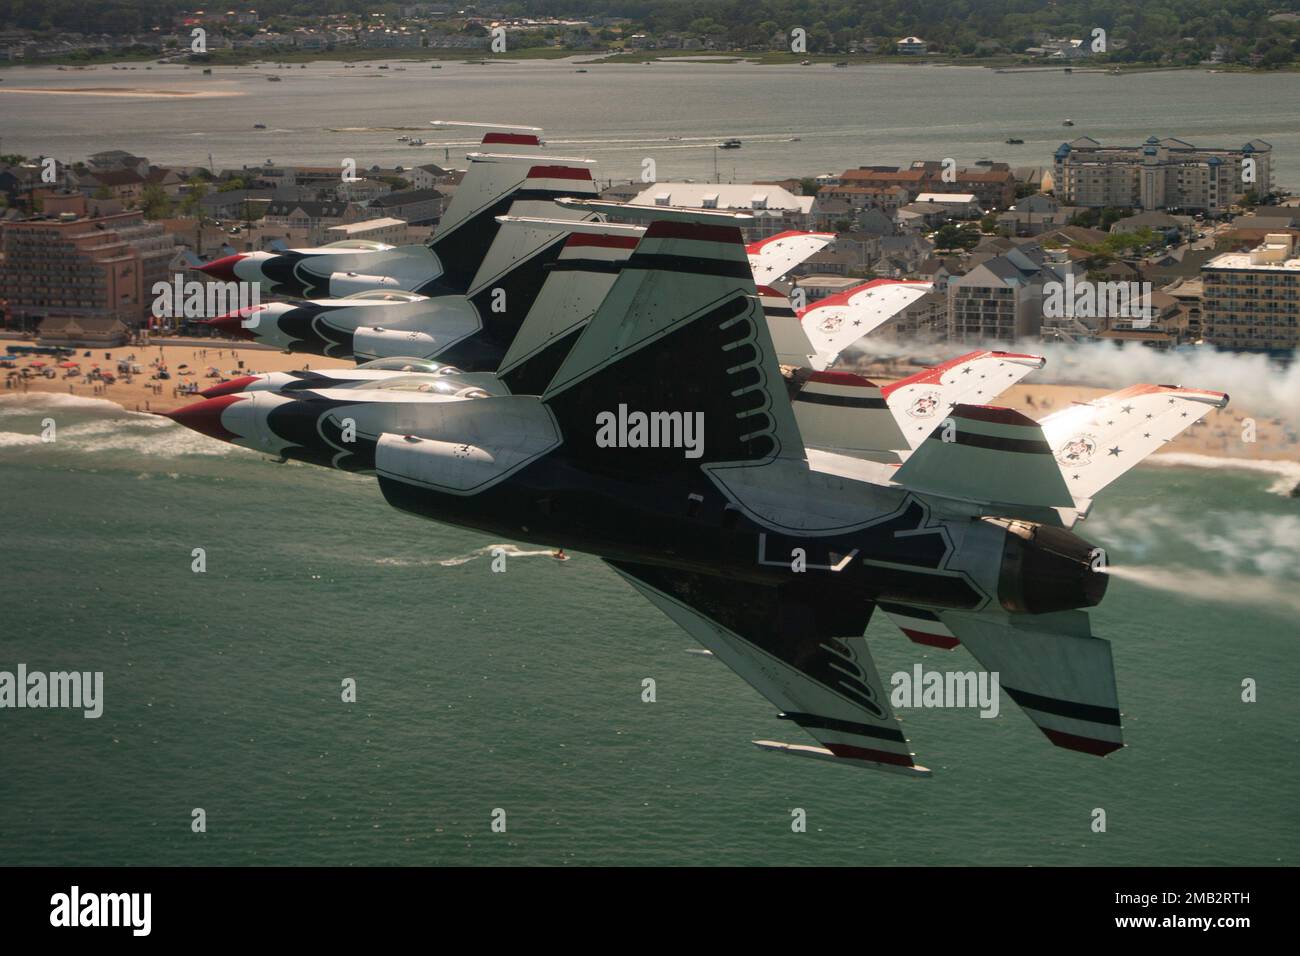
497, 217, 645, 395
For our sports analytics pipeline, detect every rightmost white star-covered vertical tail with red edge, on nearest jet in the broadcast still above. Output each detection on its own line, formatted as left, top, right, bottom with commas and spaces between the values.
1039, 385, 1227, 506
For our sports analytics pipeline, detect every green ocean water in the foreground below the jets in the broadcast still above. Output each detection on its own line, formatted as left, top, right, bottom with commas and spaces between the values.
0, 395, 1300, 865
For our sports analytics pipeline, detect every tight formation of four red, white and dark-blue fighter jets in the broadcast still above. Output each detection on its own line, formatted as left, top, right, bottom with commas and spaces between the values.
169, 121, 1227, 775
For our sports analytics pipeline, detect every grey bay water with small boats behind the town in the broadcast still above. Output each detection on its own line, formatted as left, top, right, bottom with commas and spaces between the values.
0, 57, 1300, 189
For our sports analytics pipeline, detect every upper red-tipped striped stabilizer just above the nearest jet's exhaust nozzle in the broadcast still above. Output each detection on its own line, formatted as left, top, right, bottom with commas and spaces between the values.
894, 405, 1074, 514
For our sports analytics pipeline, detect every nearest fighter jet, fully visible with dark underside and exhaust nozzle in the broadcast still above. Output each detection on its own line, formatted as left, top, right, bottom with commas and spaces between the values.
165, 207, 1227, 775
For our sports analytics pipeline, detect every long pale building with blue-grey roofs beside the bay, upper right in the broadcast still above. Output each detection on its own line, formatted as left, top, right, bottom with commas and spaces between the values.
1052, 137, 1273, 215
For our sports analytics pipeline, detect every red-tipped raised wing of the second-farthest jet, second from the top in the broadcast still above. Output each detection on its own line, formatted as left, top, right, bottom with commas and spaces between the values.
420, 153, 597, 295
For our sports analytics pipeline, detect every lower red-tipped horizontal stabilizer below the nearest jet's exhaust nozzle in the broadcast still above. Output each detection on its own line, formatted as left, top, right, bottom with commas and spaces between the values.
939, 611, 1125, 757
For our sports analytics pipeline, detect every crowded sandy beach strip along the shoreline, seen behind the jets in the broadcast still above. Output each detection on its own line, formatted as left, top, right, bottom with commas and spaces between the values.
0, 338, 1300, 462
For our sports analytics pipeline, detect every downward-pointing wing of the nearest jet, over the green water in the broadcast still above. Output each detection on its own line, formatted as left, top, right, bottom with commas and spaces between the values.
608, 561, 930, 774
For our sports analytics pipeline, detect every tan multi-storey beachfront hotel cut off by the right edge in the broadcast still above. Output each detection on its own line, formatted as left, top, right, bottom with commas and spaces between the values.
1201, 233, 1300, 351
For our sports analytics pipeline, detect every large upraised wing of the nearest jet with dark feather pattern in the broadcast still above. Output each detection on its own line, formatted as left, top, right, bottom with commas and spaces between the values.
543, 203, 803, 473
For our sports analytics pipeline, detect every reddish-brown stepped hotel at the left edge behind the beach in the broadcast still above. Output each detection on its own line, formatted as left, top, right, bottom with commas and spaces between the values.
0, 212, 176, 343
